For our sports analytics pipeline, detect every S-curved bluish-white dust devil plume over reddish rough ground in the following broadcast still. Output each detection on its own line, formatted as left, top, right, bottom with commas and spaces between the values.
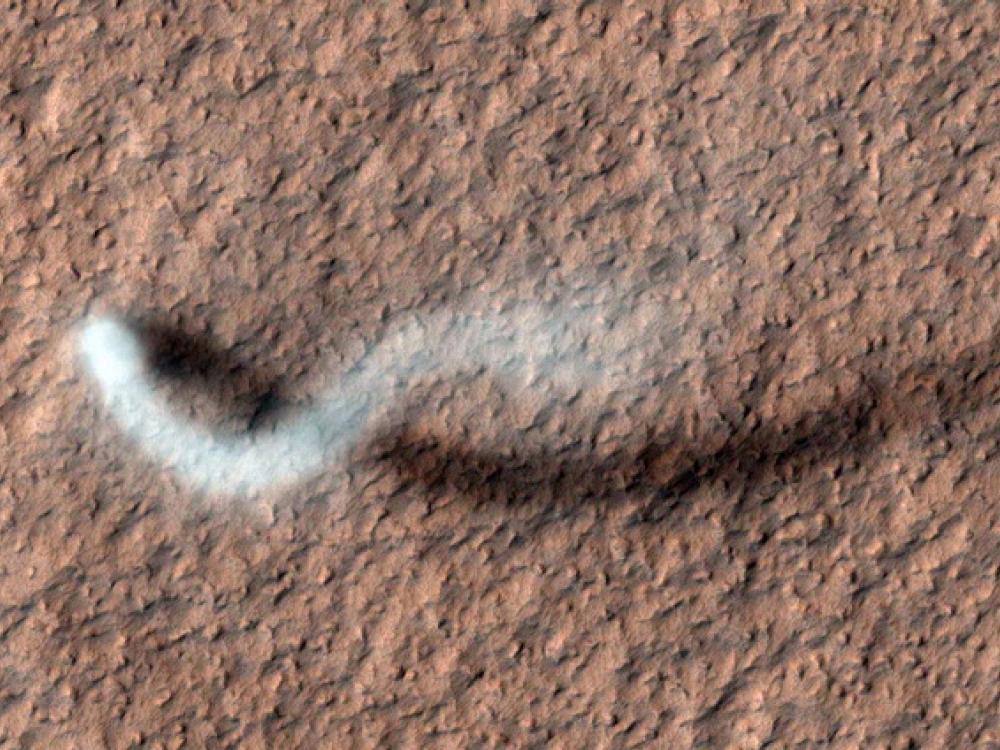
78, 304, 680, 495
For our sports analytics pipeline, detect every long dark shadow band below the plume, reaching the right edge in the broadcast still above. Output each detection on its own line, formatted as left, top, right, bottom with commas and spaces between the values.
371, 336, 1000, 523
